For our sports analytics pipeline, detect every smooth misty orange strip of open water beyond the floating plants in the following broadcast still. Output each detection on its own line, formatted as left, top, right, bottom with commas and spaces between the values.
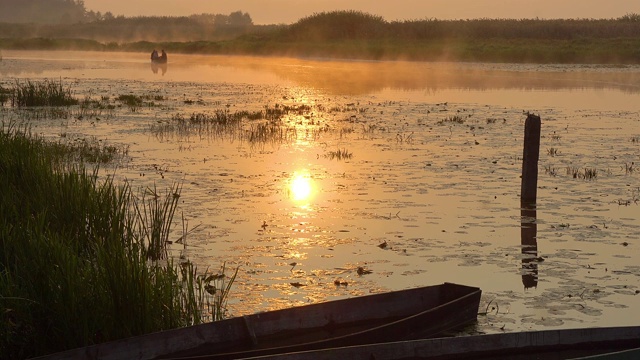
5, 51, 640, 110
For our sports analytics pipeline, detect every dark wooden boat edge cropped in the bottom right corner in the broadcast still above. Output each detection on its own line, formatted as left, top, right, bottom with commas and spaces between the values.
242, 326, 640, 360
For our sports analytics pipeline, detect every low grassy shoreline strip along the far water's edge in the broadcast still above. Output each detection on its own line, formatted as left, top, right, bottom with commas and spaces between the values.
0, 38, 640, 65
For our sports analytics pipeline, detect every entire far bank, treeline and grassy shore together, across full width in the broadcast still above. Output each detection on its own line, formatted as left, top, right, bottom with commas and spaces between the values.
0, 11, 640, 64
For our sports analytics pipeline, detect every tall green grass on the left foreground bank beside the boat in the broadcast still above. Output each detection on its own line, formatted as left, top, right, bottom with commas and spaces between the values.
0, 124, 229, 359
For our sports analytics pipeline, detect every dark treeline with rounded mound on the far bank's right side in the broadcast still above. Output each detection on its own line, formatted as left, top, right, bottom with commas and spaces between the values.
279, 11, 640, 41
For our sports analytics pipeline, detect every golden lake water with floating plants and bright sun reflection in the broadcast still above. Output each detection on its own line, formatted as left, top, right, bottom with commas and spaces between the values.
0, 51, 640, 333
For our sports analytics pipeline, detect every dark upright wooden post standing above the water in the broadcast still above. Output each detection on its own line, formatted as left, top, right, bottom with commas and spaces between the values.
520, 114, 541, 206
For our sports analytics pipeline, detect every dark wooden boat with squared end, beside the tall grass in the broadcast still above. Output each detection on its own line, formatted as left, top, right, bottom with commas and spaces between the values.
30, 283, 481, 359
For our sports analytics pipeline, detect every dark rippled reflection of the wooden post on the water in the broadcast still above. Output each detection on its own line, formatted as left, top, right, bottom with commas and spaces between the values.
520, 203, 539, 289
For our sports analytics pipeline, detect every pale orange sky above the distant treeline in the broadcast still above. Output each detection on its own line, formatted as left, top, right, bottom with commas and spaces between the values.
84, 0, 640, 25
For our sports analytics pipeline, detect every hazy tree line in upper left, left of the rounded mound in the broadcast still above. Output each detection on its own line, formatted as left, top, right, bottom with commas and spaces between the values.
0, 0, 254, 42
